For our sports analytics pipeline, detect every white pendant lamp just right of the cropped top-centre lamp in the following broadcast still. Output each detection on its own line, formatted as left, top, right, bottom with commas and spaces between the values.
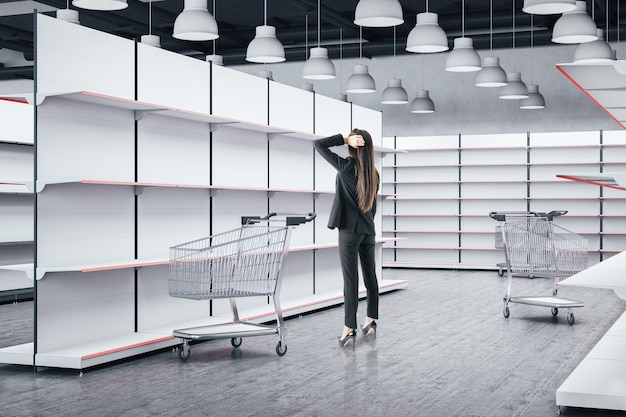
406, 8, 449, 54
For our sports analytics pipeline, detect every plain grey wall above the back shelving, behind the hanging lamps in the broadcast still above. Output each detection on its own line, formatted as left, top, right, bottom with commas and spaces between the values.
237, 44, 621, 136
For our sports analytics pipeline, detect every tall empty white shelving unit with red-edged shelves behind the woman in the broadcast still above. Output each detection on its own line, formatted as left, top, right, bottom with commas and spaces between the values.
0, 15, 407, 369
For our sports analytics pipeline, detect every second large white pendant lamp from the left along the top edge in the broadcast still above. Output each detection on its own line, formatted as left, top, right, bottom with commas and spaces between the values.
172, 0, 219, 41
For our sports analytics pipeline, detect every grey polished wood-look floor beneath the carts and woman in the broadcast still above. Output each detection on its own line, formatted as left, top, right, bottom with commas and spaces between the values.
0, 269, 626, 417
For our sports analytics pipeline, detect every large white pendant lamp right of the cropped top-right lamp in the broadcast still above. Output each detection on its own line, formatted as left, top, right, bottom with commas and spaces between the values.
552, 1, 598, 43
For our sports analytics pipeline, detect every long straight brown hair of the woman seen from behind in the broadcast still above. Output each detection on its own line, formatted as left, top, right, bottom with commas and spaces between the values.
348, 129, 378, 212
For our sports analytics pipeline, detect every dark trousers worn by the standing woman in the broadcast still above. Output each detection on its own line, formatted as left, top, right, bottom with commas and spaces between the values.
339, 230, 378, 329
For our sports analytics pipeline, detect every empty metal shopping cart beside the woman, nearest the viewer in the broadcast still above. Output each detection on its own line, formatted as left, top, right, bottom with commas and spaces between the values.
169, 213, 315, 361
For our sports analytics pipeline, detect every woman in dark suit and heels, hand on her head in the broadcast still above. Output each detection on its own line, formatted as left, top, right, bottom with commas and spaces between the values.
315, 129, 379, 349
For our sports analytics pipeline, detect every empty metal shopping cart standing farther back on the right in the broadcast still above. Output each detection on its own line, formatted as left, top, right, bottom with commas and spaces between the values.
489, 212, 588, 325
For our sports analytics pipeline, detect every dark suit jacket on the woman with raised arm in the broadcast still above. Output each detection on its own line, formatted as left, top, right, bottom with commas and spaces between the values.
315, 134, 376, 235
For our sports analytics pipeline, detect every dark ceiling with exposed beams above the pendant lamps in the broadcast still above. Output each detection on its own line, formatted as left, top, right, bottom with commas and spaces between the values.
0, 0, 626, 80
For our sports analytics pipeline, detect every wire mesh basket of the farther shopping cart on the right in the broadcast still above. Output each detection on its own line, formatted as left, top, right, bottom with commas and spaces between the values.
500, 217, 588, 277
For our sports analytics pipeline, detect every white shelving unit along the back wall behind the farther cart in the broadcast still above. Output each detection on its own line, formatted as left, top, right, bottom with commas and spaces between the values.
383, 131, 626, 269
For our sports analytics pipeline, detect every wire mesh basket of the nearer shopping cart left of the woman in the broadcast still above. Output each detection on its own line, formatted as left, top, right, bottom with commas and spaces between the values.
169, 224, 288, 300
